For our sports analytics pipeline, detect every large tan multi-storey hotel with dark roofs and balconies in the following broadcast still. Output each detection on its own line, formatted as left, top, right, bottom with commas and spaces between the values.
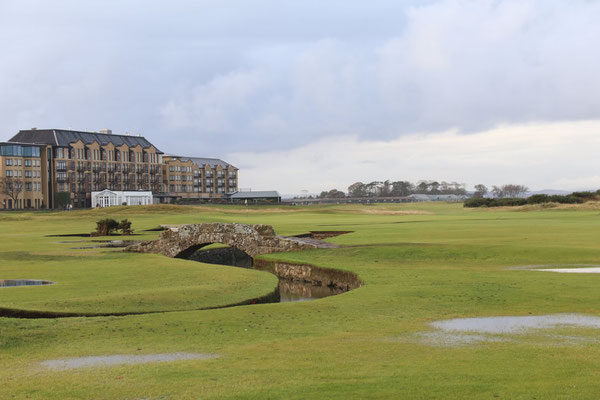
0, 129, 238, 209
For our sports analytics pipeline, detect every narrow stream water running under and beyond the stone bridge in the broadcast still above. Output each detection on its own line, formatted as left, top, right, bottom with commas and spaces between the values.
189, 247, 347, 303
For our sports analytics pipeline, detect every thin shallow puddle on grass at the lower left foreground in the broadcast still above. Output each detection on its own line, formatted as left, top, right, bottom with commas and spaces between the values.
41, 353, 219, 371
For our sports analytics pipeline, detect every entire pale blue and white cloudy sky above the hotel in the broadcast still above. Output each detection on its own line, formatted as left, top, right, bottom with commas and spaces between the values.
0, 0, 600, 193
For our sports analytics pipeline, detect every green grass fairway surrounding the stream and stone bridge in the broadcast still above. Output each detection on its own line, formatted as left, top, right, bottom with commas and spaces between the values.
0, 204, 600, 399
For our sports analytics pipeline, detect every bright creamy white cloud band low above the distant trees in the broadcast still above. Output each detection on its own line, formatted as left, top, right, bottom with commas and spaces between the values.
227, 120, 600, 193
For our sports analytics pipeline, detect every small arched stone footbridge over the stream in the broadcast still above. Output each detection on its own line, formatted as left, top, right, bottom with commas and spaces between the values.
125, 223, 337, 258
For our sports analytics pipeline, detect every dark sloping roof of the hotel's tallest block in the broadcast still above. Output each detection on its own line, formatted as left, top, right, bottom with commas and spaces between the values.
9, 129, 162, 153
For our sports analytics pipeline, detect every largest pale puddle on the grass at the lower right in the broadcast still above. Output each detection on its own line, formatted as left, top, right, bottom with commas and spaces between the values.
418, 314, 600, 346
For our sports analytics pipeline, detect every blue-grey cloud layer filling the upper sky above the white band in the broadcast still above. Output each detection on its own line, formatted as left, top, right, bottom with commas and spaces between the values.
0, 0, 600, 156
